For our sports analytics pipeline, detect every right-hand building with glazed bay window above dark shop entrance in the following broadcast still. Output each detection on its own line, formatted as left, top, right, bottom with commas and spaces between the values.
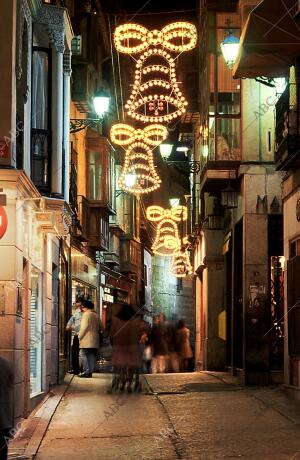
193, 1, 284, 384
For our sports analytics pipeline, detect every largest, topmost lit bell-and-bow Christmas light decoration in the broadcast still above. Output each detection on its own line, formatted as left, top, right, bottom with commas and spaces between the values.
114, 22, 197, 123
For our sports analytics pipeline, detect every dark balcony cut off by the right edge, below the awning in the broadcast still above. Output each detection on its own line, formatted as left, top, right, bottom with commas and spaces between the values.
275, 83, 300, 171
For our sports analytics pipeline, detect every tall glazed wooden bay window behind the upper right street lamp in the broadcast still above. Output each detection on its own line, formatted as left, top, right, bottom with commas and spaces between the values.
200, 13, 241, 161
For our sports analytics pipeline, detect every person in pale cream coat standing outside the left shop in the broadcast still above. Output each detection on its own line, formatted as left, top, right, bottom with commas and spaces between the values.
78, 300, 101, 378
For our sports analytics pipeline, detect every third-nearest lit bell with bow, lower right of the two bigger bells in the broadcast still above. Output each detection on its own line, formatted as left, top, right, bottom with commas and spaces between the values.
146, 206, 187, 256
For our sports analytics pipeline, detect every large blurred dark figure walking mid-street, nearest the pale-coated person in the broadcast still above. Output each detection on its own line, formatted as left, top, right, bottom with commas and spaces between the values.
110, 304, 142, 393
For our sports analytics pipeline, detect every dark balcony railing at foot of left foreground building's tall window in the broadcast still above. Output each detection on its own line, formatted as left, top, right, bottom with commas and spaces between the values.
31, 129, 51, 193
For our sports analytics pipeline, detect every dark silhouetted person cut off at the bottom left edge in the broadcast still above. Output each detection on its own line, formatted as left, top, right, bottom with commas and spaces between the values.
0, 356, 14, 460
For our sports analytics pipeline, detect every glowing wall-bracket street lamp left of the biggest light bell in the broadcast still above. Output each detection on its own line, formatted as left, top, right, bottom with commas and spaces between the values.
70, 89, 110, 133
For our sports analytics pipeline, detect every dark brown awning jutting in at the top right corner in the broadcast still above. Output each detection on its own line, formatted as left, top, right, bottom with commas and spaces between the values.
233, 0, 300, 78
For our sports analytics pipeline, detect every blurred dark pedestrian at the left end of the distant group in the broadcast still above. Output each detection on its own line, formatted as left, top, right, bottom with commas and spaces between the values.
150, 314, 168, 374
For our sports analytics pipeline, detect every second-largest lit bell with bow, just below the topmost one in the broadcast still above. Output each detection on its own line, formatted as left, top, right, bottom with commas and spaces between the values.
110, 123, 168, 194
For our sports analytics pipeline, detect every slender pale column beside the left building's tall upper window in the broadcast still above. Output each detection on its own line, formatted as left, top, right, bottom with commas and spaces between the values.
51, 47, 63, 195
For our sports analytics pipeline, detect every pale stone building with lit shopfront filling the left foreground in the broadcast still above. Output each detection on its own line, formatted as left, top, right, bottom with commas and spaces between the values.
0, 0, 73, 418
